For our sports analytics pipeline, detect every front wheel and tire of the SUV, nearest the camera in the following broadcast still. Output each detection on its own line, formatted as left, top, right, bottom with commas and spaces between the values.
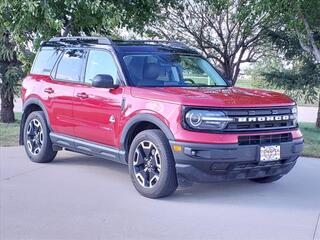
128, 129, 178, 198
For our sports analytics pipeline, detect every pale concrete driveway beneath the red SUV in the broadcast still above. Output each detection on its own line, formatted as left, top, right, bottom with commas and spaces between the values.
0, 147, 320, 240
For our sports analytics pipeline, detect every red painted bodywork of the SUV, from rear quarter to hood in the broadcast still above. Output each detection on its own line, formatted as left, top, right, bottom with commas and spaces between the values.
21, 75, 302, 148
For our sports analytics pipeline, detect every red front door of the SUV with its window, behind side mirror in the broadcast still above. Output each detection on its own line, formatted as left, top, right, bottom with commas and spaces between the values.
73, 50, 123, 146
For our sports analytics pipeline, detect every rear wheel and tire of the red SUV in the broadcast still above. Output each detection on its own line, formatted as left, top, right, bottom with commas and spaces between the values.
23, 111, 57, 163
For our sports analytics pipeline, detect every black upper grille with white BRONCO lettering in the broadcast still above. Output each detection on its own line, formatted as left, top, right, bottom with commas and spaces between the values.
224, 107, 296, 132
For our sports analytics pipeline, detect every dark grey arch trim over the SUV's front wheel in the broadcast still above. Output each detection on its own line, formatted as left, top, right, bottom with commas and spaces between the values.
120, 113, 174, 162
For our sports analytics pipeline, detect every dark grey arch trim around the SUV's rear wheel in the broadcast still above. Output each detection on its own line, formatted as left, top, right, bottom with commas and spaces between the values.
19, 98, 51, 145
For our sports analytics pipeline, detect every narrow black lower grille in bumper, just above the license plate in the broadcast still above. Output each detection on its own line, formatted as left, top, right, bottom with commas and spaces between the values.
238, 133, 292, 145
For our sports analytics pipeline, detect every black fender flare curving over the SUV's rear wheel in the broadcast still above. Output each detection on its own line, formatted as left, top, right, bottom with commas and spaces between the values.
19, 97, 52, 145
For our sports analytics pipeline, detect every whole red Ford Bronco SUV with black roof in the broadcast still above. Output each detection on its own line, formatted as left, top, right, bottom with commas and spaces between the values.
20, 37, 303, 198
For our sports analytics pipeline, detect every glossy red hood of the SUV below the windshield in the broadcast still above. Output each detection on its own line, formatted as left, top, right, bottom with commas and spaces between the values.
132, 87, 294, 107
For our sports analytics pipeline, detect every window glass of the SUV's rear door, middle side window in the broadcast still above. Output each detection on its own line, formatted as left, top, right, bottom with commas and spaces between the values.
56, 49, 85, 82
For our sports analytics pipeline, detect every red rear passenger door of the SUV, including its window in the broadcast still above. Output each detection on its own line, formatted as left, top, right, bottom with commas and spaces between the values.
44, 49, 86, 136
